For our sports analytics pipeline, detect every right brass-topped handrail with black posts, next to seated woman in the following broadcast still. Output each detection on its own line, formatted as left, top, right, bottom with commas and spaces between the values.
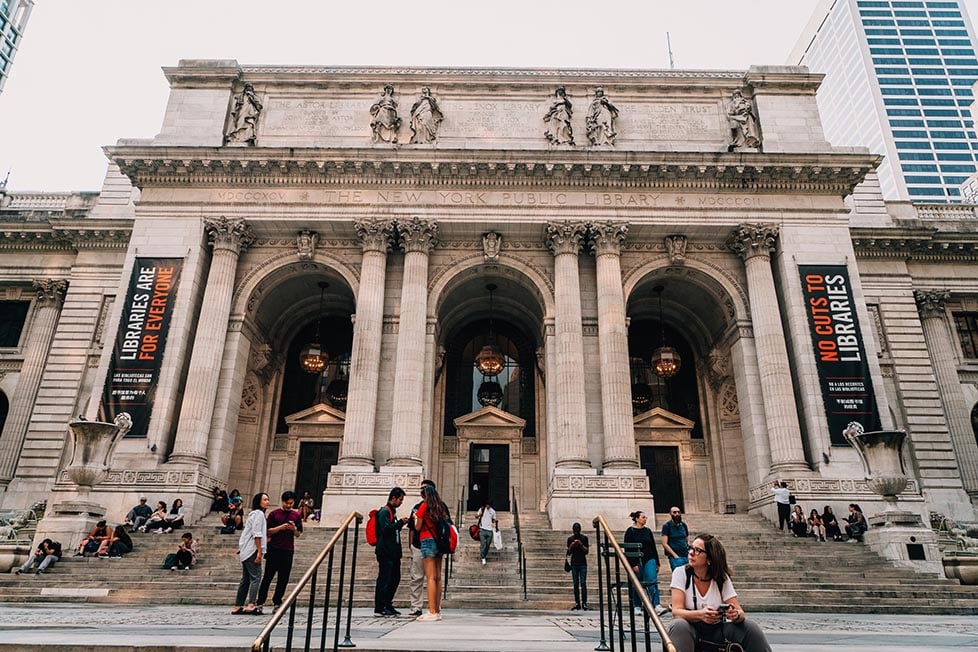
592, 514, 676, 652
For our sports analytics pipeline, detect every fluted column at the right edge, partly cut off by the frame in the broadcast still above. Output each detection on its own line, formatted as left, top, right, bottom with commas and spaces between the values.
914, 290, 978, 504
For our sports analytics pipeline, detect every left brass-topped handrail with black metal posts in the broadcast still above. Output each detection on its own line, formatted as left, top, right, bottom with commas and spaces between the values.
251, 512, 363, 652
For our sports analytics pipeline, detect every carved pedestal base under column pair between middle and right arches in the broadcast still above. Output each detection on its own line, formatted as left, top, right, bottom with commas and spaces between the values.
547, 468, 655, 531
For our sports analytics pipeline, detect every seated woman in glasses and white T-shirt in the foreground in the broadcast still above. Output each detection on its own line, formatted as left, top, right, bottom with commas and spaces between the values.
669, 534, 771, 652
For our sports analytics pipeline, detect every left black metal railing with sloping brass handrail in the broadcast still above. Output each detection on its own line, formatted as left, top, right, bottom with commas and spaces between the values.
251, 512, 363, 652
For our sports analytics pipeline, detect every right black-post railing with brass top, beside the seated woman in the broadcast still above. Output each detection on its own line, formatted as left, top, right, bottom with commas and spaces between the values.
593, 515, 676, 652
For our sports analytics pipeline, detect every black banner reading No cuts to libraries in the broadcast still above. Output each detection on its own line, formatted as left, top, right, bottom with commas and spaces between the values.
798, 265, 880, 446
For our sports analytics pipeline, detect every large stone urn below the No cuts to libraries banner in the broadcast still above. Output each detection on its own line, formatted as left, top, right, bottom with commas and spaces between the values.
843, 421, 909, 511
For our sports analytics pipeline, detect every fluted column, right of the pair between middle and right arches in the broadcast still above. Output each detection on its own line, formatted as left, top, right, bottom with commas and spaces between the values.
591, 222, 638, 469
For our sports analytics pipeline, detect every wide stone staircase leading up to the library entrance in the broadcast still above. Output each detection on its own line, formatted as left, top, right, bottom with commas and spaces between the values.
0, 513, 978, 615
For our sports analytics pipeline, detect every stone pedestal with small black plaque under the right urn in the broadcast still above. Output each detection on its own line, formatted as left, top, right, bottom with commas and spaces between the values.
863, 511, 944, 578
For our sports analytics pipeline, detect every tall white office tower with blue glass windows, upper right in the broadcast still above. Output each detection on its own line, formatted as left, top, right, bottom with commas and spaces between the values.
790, 0, 978, 202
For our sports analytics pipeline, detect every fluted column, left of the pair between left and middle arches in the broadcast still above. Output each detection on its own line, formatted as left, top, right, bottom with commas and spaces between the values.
339, 221, 394, 470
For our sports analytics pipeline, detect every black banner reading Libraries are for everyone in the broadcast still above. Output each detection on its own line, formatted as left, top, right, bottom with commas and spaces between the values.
101, 258, 183, 437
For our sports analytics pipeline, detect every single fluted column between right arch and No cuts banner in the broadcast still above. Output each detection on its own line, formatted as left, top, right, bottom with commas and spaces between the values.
730, 224, 810, 474
